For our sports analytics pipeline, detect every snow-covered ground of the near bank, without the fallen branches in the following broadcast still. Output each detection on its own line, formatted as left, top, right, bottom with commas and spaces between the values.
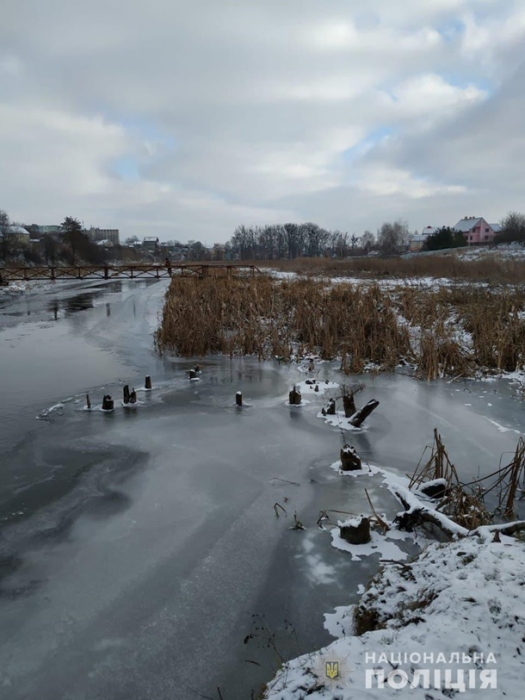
264, 537, 525, 700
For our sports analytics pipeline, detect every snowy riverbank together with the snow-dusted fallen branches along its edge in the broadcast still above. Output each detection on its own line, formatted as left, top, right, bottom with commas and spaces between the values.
264, 442, 525, 700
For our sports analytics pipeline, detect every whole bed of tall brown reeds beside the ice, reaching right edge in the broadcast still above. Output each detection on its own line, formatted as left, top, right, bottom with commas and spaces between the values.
155, 275, 525, 379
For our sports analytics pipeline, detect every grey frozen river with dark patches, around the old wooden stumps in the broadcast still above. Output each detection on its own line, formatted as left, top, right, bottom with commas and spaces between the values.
0, 281, 525, 700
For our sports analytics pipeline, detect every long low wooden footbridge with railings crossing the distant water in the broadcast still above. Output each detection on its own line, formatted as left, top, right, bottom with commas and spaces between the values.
0, 263, 260, 284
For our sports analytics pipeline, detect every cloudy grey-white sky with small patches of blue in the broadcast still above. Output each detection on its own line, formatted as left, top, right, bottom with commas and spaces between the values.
0, 0, 525, 245
